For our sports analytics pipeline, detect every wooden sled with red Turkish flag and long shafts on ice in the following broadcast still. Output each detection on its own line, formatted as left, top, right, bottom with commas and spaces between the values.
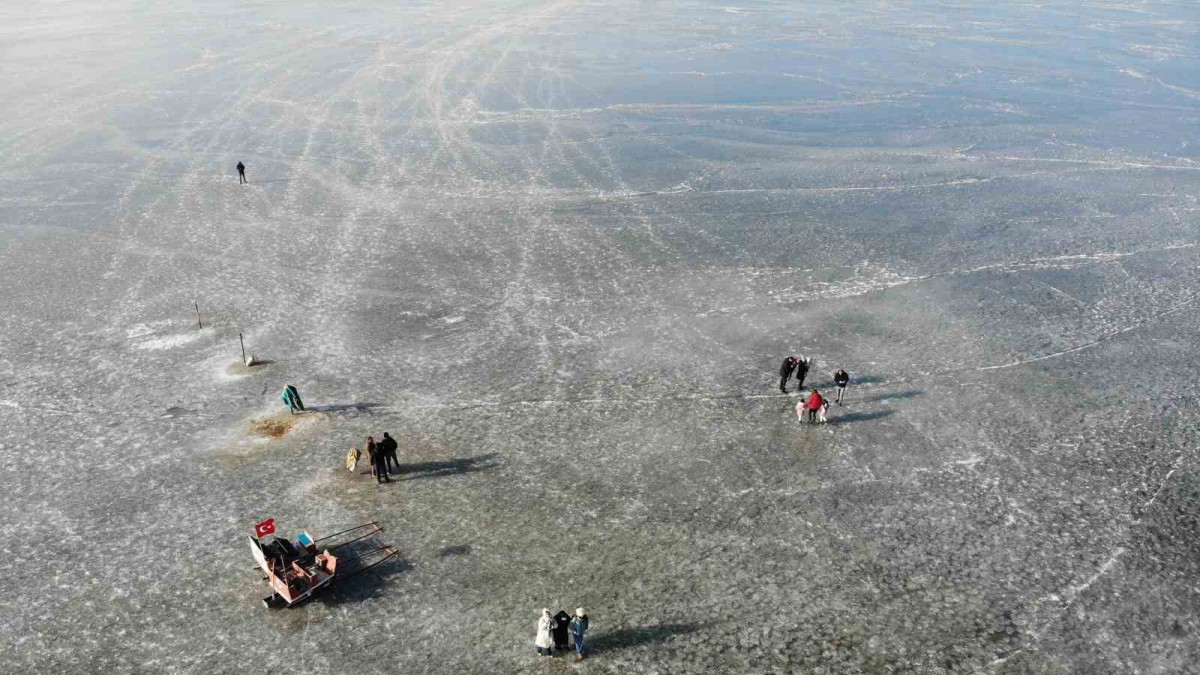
250, 518, 400, 608
